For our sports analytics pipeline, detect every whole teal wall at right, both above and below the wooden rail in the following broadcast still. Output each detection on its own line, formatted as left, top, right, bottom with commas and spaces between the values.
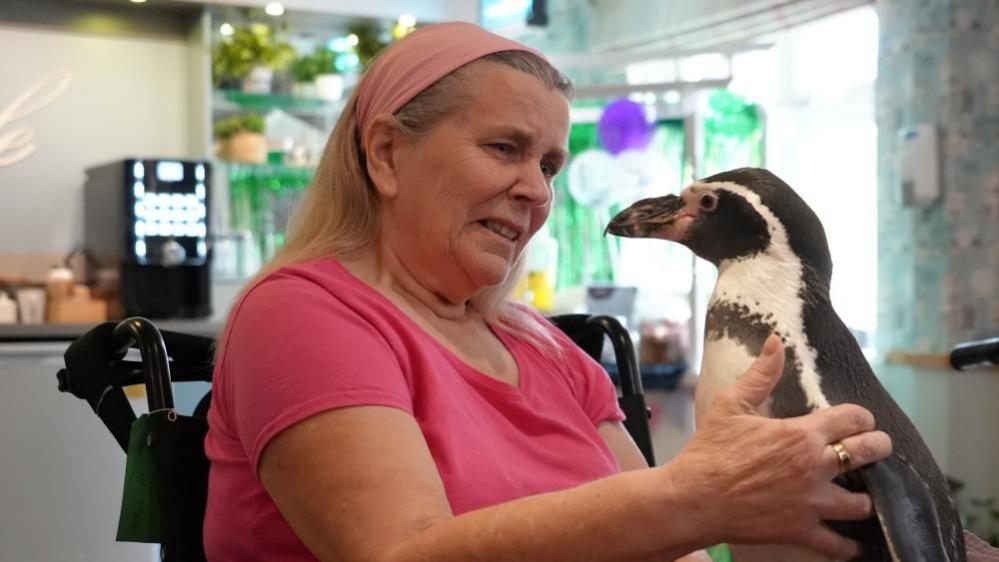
875, 0, 999, 520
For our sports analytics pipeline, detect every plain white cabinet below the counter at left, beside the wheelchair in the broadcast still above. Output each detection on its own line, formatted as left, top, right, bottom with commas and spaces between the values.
0, 343, 159, 562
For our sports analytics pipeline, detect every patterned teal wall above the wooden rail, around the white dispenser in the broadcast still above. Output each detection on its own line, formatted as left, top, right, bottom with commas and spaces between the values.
876, 0, 999, 353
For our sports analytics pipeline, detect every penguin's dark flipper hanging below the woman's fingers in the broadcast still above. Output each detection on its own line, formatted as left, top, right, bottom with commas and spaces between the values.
858, 455, 965, 562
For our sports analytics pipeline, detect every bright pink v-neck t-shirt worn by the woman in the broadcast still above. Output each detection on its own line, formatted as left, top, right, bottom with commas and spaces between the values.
205, 259, 624, 562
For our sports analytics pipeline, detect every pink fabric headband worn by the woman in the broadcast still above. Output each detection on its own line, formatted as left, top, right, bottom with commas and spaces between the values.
355, 22, 547, 134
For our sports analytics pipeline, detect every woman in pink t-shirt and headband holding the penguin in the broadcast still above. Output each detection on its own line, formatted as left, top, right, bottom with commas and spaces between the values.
205, 23, 891, 562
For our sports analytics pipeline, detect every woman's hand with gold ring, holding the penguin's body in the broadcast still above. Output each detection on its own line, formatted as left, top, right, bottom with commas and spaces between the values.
667, 336, 891, 560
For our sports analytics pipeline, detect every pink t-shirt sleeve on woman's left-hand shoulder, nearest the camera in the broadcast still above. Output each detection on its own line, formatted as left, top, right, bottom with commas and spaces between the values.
222, 275, 413, 469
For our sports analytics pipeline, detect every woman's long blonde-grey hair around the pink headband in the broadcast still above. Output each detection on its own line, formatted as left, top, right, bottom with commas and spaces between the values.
219, 51, 573, 350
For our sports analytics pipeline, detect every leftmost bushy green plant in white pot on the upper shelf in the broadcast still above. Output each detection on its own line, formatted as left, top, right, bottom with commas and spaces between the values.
212, 23, 295, 94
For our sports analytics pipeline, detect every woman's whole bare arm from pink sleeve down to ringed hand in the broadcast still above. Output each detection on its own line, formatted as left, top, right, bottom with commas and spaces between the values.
259, 338, 890, 562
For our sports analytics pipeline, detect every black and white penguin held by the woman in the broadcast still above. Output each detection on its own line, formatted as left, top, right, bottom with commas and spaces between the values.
605, 168, 966, 562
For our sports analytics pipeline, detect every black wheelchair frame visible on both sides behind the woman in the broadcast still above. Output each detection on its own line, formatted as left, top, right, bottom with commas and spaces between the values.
57, 314, 655, 562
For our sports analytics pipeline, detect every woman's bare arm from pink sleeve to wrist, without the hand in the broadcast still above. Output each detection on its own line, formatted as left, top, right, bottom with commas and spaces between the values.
260, 406, 711, 562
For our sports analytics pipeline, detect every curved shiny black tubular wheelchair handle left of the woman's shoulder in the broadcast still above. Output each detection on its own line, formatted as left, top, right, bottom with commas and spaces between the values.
114, 316, 174, 412
